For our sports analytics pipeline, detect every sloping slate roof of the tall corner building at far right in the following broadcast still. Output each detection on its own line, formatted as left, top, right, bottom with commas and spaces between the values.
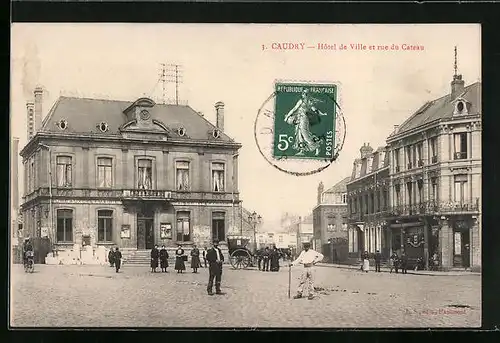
389, 82, 482, 138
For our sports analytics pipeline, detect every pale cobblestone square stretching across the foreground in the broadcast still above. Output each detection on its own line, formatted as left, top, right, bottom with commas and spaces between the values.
11, 265, 481, 328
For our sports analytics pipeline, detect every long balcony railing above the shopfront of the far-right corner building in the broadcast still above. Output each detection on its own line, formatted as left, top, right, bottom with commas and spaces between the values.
389, 198, 479, 216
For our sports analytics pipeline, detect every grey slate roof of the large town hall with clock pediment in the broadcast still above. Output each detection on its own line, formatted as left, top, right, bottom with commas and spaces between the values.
40, 96, 233, 142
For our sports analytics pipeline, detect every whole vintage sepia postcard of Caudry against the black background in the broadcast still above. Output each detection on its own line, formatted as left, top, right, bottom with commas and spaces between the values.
9, 23, 482, 329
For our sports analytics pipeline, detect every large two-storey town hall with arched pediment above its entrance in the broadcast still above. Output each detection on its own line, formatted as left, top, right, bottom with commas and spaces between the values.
20, 97, 242, 255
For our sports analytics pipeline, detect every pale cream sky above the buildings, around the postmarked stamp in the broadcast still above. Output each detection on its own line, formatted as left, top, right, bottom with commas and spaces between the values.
10, 23, 481, 225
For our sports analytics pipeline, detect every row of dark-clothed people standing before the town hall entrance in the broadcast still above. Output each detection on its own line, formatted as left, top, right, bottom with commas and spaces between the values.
151, 245, 207, 274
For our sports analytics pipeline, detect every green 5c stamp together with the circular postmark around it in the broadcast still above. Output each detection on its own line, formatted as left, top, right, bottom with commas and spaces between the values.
254, 80, 346, 176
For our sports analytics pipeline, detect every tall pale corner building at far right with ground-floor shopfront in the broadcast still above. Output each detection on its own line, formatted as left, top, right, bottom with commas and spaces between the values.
387, 75, 482, 270
